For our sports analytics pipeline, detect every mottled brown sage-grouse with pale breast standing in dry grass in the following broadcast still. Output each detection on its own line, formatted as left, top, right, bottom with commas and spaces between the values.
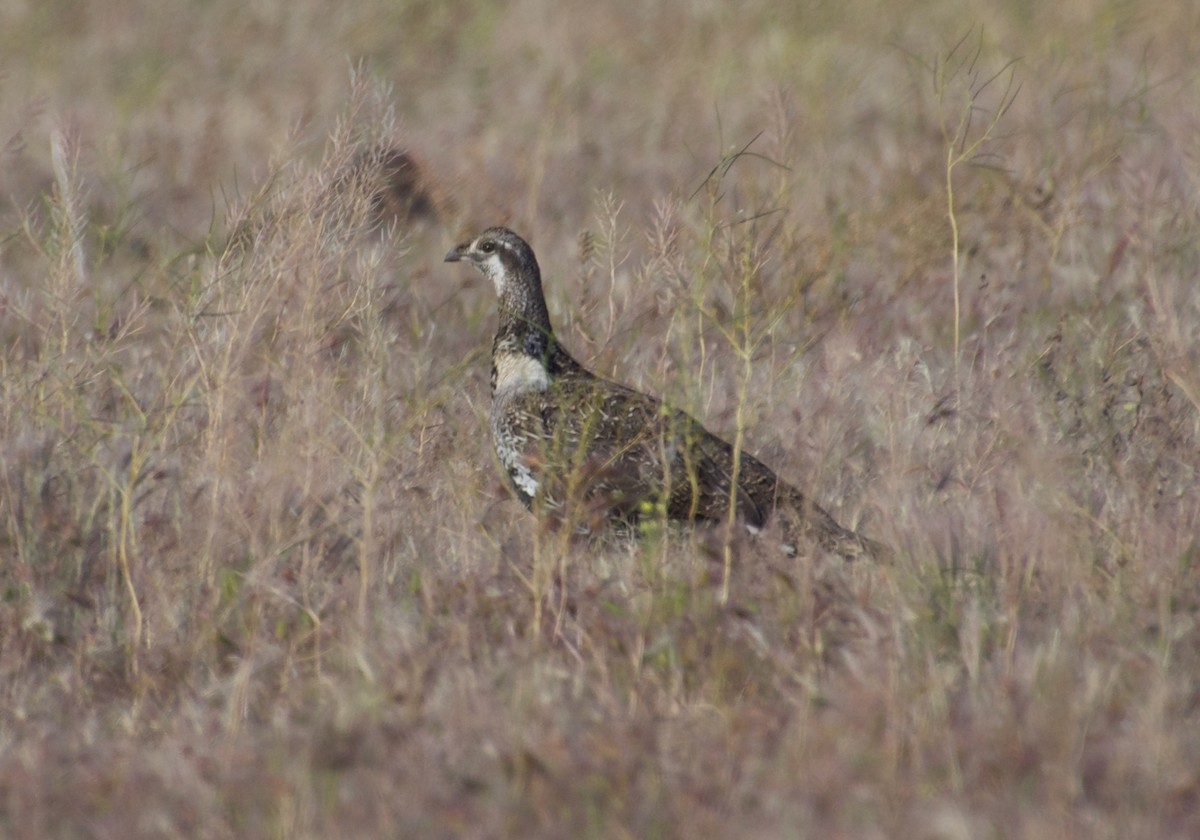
446, 227, 886, 558
